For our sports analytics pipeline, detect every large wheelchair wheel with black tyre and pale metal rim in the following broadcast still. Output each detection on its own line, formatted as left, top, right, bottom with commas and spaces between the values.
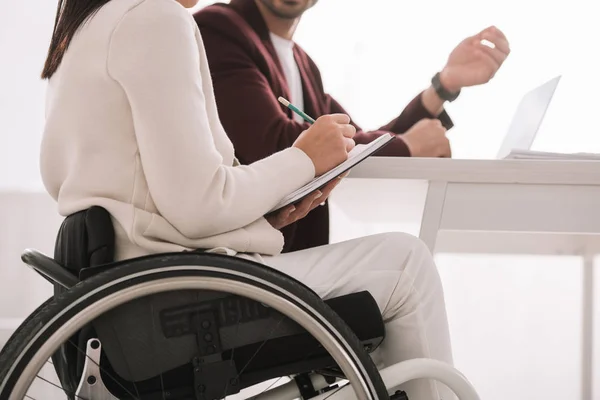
0, 253, 389, 400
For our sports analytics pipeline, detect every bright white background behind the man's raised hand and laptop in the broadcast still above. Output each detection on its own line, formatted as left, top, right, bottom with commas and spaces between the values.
297, 0, 600, 158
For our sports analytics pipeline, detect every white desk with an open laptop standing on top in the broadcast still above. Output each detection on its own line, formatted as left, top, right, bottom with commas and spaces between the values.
332, 157, 600, 400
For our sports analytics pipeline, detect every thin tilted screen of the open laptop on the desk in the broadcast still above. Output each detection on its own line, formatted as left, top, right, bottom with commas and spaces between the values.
496, 75, 561, 159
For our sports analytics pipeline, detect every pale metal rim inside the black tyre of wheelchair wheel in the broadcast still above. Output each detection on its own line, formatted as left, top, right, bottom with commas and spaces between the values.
0, 266, 377, 400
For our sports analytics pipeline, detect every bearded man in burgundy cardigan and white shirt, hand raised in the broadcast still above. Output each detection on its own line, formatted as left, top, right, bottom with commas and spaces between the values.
194, 0, 510, 252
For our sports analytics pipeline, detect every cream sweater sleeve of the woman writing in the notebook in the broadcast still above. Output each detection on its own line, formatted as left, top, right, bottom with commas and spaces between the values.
107, 2, 315, 238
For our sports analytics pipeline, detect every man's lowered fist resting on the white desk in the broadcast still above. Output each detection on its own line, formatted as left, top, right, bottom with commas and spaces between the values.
400, 119, 451, 157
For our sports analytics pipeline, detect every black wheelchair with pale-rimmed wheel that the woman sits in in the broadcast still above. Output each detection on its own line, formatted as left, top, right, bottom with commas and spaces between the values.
0, 207, 479, 400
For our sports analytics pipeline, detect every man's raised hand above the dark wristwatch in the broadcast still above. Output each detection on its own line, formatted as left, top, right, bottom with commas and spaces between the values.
440, 26, 510, 93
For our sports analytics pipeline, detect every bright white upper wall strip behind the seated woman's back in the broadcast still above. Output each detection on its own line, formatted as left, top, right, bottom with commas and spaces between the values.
0, 0, 57, 188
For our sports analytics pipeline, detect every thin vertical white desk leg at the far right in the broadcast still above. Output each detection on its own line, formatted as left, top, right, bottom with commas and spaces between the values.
581, 254, 594, 400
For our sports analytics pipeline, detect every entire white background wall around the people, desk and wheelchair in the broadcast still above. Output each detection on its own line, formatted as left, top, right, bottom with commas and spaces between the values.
0, 0, 600, 400
